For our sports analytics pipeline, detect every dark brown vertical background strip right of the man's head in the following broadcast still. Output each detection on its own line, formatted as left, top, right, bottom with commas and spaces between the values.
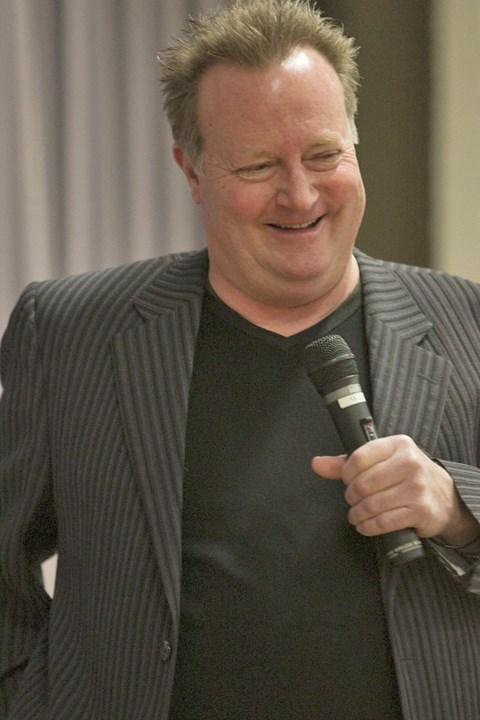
316, 0, 431, 265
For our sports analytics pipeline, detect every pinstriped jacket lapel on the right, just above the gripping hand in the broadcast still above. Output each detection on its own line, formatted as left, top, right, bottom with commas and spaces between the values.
357, 253, 451, 453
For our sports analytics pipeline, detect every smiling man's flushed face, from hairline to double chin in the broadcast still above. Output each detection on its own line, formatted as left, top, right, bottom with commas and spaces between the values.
174, 48, 365, 307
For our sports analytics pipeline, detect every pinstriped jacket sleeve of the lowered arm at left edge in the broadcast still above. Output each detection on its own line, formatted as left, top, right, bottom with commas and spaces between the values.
0, 285, 56, 717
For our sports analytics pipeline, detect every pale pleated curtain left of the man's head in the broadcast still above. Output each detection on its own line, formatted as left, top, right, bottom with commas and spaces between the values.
0, 0, 219, 333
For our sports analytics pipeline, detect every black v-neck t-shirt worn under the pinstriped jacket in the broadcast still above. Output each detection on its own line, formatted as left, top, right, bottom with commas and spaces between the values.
170, 288, 401, 720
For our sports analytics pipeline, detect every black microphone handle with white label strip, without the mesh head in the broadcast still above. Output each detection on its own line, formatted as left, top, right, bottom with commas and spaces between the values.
323, 375, 425, 565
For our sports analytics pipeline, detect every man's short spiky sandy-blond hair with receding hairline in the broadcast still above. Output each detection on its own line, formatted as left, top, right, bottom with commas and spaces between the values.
158, 0, 359, 164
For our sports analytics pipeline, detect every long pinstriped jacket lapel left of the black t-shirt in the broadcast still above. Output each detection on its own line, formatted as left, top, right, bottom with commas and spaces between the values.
114, 252, 207, 625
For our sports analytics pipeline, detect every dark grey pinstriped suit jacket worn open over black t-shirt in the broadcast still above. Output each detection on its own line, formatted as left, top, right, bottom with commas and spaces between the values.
0, 251, 480, 720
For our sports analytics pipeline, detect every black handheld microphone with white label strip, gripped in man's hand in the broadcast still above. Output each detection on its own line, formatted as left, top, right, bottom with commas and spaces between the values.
305, 335, 425, 565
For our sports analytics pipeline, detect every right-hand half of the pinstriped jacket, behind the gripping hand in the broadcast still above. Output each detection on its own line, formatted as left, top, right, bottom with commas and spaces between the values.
359, 252, 480, 720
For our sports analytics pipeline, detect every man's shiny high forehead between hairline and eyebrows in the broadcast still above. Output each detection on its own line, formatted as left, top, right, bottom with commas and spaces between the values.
198, 48, 348, 153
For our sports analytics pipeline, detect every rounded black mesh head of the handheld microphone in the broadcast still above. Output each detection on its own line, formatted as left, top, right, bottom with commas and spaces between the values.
305, 335, 358, 389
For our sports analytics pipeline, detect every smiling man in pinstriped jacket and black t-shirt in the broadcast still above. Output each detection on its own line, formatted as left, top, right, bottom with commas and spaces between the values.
0, 0, 480, 720
